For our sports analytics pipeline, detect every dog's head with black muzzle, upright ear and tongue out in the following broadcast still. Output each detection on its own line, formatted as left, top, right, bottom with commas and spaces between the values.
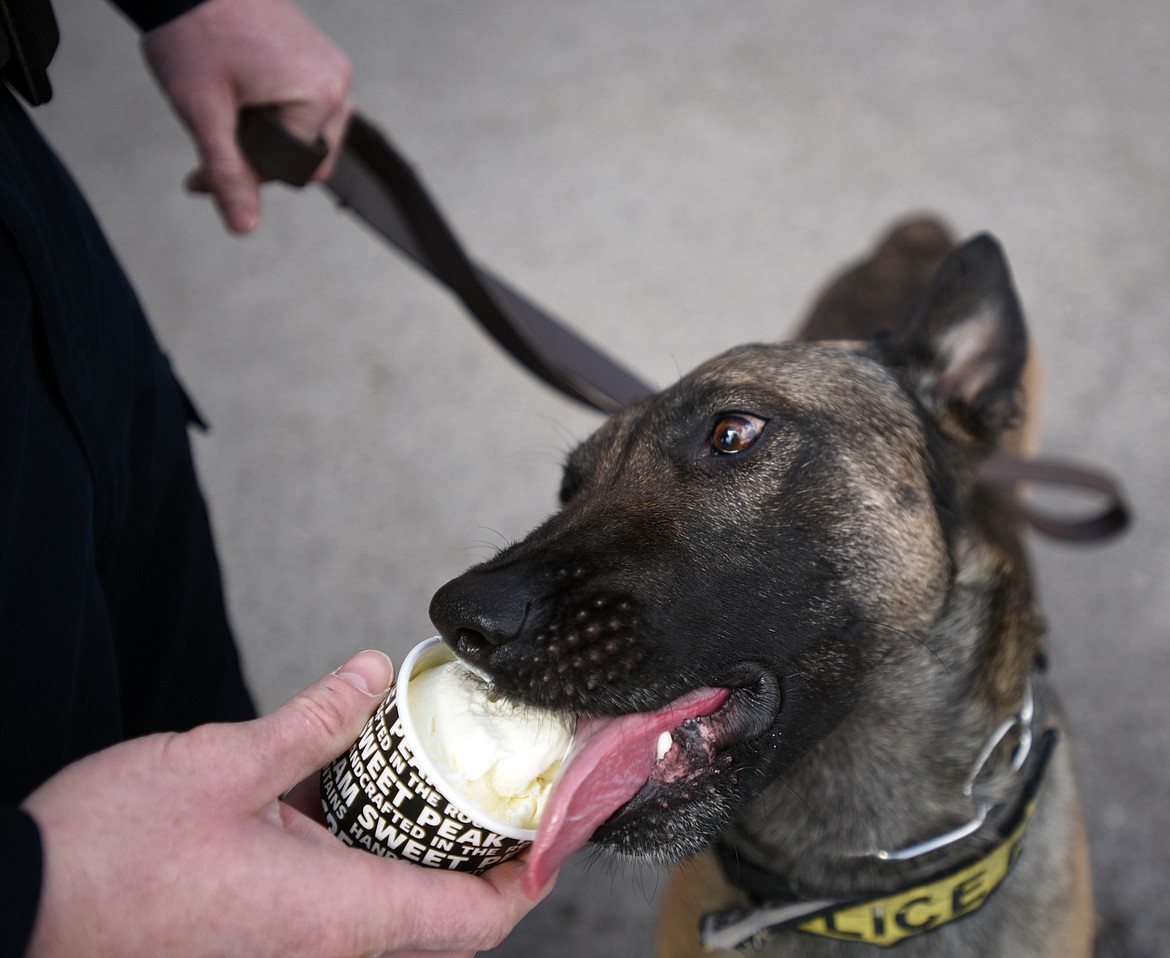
431, 236, 1025, 884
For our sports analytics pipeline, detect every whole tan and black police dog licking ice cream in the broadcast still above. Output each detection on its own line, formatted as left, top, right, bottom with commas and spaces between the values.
431, 219, 1093, 958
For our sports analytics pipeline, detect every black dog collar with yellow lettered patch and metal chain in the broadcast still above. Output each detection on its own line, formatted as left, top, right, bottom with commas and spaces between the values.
700, 676, 1059, 951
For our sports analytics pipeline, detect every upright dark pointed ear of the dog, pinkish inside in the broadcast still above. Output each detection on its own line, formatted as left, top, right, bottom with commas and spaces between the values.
885, 234, 1027, 446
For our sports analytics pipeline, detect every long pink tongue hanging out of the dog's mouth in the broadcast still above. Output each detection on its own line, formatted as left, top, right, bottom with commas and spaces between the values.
521, 689, 730, 898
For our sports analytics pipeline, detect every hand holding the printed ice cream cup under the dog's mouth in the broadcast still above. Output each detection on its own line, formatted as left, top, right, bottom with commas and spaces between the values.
23, 652, 551, 958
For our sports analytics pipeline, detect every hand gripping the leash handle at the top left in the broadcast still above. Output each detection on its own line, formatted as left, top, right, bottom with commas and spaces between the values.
143, 0, 351, 233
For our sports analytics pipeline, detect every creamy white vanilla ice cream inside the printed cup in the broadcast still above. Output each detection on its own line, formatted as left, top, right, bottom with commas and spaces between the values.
406, 661, 573, 829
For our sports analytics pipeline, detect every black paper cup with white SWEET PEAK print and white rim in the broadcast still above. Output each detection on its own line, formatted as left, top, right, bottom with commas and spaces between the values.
321, 636, 552, 875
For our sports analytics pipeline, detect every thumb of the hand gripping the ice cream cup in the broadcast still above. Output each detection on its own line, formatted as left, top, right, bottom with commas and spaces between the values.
248, 649, 394, 801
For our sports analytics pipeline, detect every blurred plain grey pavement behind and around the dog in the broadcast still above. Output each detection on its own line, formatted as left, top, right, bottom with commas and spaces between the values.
37, 0, 1170, 958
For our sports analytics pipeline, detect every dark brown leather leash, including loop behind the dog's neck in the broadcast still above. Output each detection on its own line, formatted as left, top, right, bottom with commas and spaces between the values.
238, 108, 1130, 542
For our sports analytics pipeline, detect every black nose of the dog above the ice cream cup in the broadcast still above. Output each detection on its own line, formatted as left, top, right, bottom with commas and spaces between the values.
431, 570, 528, 666
